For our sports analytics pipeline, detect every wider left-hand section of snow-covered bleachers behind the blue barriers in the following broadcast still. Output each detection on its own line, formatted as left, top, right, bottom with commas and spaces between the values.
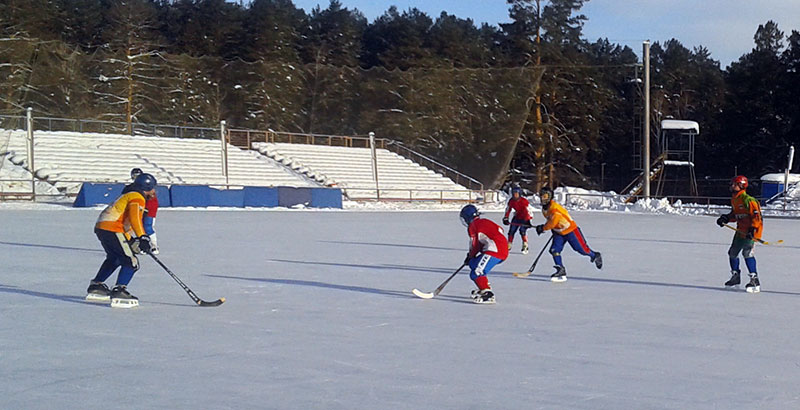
0, 130, 320, 194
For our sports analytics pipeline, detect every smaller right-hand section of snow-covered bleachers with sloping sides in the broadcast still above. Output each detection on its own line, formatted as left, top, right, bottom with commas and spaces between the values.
253, 142, 475, 200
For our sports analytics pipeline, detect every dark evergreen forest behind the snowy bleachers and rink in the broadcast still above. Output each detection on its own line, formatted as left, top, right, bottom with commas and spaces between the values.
0, 0, 800, 194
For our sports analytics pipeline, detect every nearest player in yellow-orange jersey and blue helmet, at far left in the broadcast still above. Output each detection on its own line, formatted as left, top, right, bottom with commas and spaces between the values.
86, 174, 156, 308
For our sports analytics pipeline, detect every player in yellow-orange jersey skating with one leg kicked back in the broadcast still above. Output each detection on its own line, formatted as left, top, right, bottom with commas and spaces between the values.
536, 187, 603, 282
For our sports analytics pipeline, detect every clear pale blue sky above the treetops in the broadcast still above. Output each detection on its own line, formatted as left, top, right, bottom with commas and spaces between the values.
293, 0, 800, 68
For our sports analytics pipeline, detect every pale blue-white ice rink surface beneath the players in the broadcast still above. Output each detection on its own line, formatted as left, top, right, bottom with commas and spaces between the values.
0, 207, 800, 410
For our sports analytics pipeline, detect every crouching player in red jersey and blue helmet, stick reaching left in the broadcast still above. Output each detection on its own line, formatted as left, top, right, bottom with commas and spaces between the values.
460, 204, 508, 303
